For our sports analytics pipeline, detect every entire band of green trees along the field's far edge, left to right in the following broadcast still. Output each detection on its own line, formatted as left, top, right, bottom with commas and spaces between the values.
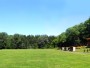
0, 18, 90, 49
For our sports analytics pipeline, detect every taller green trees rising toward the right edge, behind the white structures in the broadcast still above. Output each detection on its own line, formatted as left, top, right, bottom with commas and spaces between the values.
56, 18, 90, 47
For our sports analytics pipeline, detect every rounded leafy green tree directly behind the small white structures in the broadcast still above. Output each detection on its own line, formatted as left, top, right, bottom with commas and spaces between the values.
66, 25, 80, 46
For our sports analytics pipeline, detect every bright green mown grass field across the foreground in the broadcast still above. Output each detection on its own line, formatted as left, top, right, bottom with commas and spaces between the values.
0, 49, 90, 68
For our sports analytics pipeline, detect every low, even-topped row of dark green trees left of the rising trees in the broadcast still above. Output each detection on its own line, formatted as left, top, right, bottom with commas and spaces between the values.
0, 32, 56, 49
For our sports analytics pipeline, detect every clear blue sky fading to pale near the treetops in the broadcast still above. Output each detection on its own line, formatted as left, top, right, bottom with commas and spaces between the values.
0, 0, 90, 36
